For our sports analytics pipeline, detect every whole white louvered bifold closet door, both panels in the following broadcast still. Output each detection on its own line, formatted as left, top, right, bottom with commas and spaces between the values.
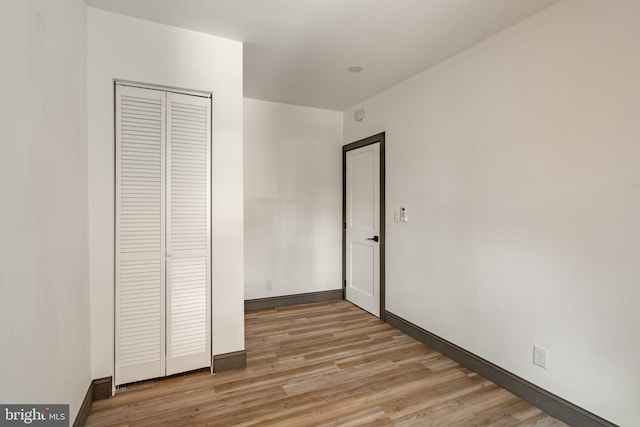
115, 84, 211, 385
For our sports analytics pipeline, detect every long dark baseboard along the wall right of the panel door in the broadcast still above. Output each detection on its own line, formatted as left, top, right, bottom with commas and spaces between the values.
386, 311, 617, 427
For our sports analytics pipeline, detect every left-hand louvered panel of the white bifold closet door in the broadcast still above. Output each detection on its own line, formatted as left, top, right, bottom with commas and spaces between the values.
115, 86, 166, 385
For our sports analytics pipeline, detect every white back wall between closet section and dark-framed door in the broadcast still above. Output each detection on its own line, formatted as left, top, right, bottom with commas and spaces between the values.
244, 99, 342, 299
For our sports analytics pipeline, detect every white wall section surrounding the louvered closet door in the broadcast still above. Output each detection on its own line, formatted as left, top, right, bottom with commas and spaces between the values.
88, 8, 244, 378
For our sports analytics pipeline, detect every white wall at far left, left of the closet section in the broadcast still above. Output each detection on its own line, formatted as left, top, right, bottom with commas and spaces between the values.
0, 0, 91, 421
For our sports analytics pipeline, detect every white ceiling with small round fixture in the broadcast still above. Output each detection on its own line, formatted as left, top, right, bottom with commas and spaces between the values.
87, 0, 560, 111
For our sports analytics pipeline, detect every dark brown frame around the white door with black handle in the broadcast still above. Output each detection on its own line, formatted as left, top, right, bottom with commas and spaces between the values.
342, 132, 387, 321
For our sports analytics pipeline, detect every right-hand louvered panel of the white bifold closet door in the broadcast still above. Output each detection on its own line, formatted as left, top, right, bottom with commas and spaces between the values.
167, 93, 211, 375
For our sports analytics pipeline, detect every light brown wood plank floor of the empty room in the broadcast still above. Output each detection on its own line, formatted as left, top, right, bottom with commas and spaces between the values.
87, 301, 565, 427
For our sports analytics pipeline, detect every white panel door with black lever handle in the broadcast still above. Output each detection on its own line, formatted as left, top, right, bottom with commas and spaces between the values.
345, 143, 380, 316
